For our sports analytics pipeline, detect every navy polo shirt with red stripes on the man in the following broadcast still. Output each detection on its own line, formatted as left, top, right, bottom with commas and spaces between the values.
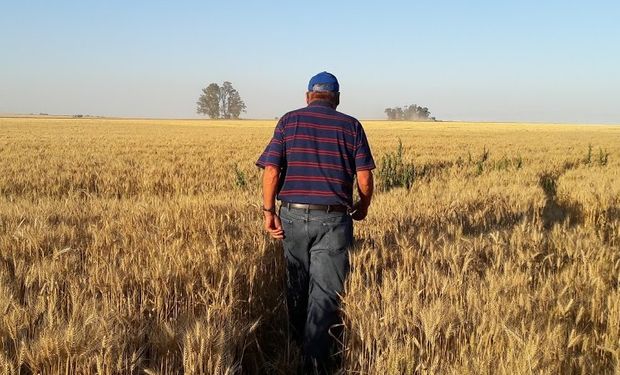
256, 101, 375, 207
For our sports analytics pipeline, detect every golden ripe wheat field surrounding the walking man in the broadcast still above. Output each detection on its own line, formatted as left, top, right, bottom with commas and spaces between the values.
0, 118, 620, 374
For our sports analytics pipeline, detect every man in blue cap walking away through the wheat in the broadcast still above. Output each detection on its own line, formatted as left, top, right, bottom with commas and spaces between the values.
256, 72, 375, 371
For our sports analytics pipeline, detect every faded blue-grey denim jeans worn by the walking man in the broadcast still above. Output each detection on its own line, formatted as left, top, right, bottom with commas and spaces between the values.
280, 206, 353, 363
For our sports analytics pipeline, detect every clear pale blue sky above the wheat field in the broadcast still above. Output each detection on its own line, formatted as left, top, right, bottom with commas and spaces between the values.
0, 0, 620, 123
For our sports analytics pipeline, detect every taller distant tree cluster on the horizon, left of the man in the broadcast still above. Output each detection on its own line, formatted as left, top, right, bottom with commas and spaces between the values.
196, 81, 246, 119
